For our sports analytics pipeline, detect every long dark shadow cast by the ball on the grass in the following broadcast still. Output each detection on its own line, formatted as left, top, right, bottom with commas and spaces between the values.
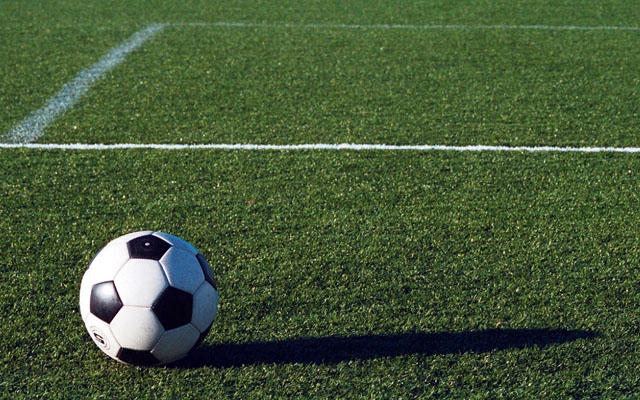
174, 329, 598, 368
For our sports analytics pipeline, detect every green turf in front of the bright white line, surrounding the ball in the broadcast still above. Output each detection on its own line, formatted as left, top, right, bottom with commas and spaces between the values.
0, 150, 640, 398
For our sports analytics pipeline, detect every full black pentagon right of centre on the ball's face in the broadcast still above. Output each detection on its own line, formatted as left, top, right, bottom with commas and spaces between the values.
151, 286, 193, 331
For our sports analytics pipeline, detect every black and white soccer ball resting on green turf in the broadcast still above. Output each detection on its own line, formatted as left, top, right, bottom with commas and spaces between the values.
80, 231, 218, 365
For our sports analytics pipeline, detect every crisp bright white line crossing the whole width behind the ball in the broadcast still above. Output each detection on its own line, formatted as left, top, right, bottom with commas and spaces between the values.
0, 143, 640, 153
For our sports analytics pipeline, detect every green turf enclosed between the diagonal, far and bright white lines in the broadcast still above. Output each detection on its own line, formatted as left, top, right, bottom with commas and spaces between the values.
42, 26, 640, 146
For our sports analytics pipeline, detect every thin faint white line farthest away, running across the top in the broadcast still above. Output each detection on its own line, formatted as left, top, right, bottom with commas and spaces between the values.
176, 22, 640, 31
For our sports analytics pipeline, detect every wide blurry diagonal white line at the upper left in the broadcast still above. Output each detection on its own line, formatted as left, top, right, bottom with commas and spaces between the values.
2, 24, 167, 143
